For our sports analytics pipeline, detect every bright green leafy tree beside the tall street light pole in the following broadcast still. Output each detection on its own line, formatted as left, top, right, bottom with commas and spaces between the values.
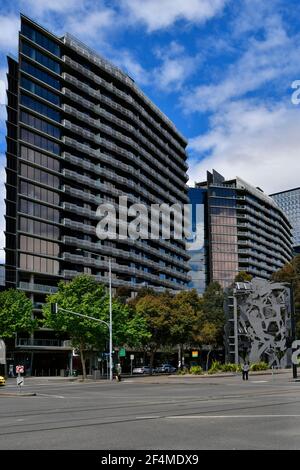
44, 275, 148, 378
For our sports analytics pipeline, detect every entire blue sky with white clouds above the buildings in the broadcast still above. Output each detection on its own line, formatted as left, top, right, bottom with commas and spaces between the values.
0, 0, 300, 255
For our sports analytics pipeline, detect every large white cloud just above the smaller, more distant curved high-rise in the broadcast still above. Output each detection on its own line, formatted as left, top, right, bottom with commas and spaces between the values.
189, 101, 300, 193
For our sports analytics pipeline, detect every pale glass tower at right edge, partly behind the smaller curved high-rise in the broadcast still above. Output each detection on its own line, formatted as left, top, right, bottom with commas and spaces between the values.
270, 188, 300, 254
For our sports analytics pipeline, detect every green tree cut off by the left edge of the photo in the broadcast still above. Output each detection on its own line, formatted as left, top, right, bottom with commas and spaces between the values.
0, 289, 37, 338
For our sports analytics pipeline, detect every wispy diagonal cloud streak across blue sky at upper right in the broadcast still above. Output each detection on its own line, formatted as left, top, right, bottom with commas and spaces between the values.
181, 8, 300, 113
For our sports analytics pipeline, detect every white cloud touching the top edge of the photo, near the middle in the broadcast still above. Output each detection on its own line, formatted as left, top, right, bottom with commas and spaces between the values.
122, 0, 228, 32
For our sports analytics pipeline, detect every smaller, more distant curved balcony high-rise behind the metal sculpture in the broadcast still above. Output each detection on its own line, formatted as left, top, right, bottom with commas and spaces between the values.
189, 170, 292, 292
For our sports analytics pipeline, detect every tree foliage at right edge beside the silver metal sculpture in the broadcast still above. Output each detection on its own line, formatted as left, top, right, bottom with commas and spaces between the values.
272, 255, 300, 338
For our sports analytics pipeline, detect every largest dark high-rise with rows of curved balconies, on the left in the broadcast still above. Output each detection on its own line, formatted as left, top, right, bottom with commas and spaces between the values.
6, 15, 189, 372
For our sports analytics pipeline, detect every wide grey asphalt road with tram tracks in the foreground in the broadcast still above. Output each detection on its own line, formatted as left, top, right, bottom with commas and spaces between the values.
0, 372, 300, 450
